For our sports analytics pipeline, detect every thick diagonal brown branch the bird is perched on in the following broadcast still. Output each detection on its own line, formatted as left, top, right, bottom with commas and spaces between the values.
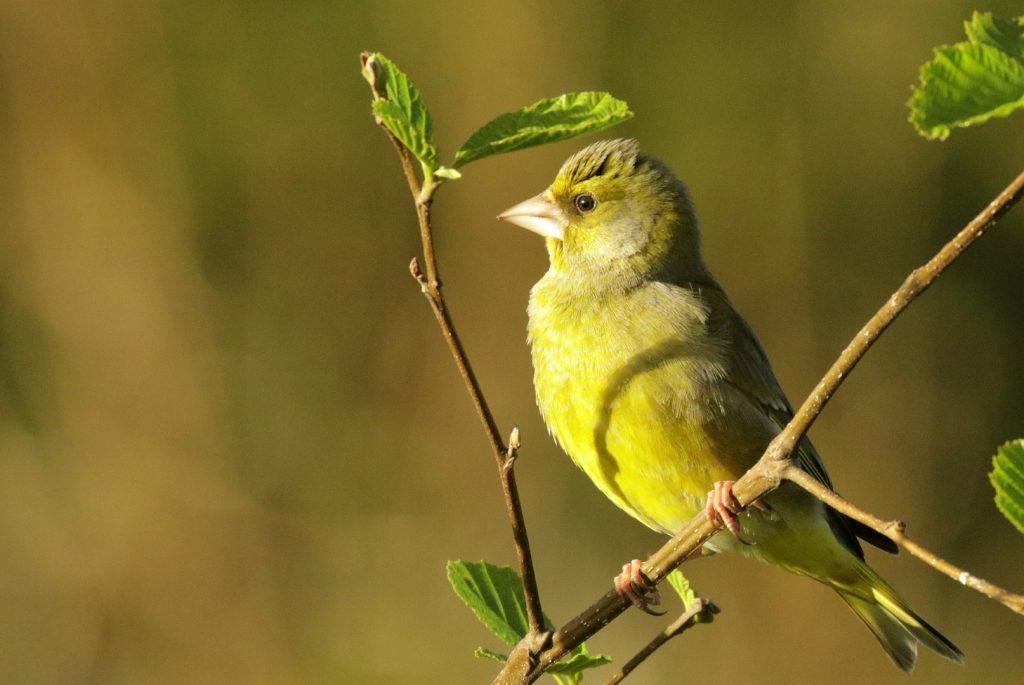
495, 172, 1024, 683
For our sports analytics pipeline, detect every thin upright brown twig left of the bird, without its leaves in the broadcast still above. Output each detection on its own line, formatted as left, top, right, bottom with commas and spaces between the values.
359, 52, 546, 634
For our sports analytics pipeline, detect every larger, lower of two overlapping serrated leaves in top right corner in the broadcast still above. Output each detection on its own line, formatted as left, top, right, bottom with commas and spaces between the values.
907, 43, 1024, 139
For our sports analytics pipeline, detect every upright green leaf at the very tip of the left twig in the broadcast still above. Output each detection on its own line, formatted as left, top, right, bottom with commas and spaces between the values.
362, 52, 439, 172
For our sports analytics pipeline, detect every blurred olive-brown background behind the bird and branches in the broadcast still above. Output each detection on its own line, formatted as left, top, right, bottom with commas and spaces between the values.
0, 0, 1024, 684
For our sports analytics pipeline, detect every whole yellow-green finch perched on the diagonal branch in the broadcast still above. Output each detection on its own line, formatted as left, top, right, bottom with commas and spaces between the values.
498, 139, 964, 672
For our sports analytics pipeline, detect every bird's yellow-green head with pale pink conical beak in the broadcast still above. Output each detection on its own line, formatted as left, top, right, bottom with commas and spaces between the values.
498, 139, 703, 275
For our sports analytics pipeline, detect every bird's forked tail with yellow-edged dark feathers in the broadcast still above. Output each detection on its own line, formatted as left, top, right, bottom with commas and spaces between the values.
834, 564, 964, 673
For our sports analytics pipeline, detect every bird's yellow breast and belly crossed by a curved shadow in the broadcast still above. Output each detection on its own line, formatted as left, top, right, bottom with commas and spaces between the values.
529, 274, 734, 532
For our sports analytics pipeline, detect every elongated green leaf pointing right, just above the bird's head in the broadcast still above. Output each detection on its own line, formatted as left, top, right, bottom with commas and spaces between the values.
453, 92, 633, 167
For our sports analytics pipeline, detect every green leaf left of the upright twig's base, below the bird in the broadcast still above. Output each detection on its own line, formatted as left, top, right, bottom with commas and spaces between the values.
447, 561, 529, 645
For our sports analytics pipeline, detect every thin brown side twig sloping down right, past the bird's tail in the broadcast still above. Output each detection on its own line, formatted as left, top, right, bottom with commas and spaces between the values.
785, 467, 1024, 614
